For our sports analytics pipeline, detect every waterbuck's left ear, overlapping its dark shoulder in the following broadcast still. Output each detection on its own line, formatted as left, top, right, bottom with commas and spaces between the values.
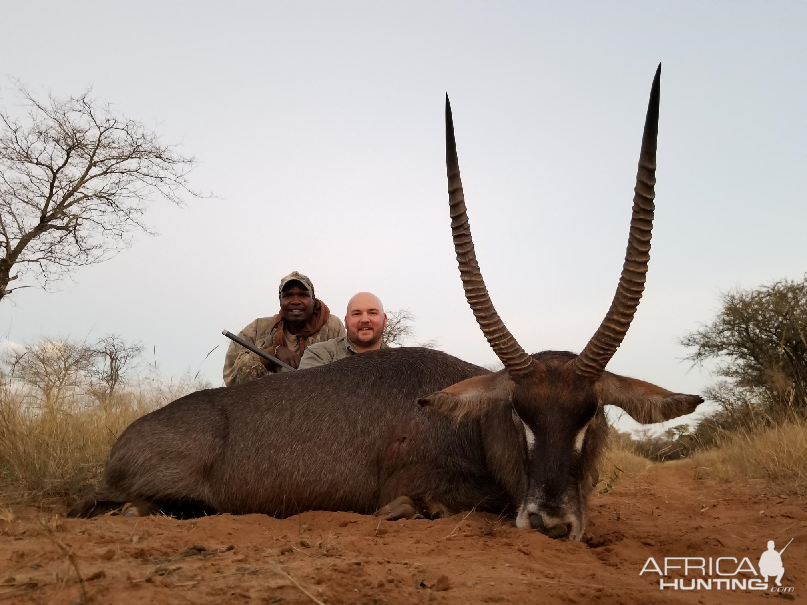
418, 370, 513, 420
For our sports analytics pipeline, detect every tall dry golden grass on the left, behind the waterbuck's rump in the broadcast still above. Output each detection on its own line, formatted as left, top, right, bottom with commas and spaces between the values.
0, 378, 209, 506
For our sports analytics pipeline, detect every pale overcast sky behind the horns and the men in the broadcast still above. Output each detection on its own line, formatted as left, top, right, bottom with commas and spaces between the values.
0, 0, 807, 432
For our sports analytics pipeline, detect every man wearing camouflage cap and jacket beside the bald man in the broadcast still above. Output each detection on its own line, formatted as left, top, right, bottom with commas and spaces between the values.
224, 271, 345, 386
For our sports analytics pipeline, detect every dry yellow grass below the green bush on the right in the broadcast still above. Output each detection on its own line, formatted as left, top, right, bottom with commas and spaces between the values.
691, 418, 807, 495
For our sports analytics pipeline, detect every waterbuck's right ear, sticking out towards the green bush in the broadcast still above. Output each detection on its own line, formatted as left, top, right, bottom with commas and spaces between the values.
594, 372, 703, 424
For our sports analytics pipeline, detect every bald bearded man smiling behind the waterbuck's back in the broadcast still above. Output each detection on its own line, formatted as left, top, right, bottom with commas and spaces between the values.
299, 292, 387, 370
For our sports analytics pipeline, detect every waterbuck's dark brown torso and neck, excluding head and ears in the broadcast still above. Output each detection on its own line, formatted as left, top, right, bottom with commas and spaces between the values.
69, 349, 509, 516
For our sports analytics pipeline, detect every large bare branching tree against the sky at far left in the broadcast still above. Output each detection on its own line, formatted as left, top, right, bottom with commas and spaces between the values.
0, 84, 198, 300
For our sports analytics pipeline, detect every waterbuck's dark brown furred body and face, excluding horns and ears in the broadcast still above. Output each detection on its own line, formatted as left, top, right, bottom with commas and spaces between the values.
69, 348, 700, 536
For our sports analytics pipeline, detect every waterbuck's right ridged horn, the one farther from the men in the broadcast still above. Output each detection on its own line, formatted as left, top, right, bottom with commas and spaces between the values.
576, 63, 661, 381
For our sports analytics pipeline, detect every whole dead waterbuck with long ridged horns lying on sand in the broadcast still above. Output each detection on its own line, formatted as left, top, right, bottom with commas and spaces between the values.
69, 67, 703, 540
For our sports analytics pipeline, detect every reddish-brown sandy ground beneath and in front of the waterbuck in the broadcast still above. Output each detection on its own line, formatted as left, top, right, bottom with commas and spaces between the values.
0, 463, 807, 605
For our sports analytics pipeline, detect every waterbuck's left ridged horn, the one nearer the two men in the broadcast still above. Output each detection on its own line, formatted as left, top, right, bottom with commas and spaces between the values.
446, 95, 532, 377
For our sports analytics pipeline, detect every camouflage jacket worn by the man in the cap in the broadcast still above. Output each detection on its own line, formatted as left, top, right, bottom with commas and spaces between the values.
223, 315, 345, 387
